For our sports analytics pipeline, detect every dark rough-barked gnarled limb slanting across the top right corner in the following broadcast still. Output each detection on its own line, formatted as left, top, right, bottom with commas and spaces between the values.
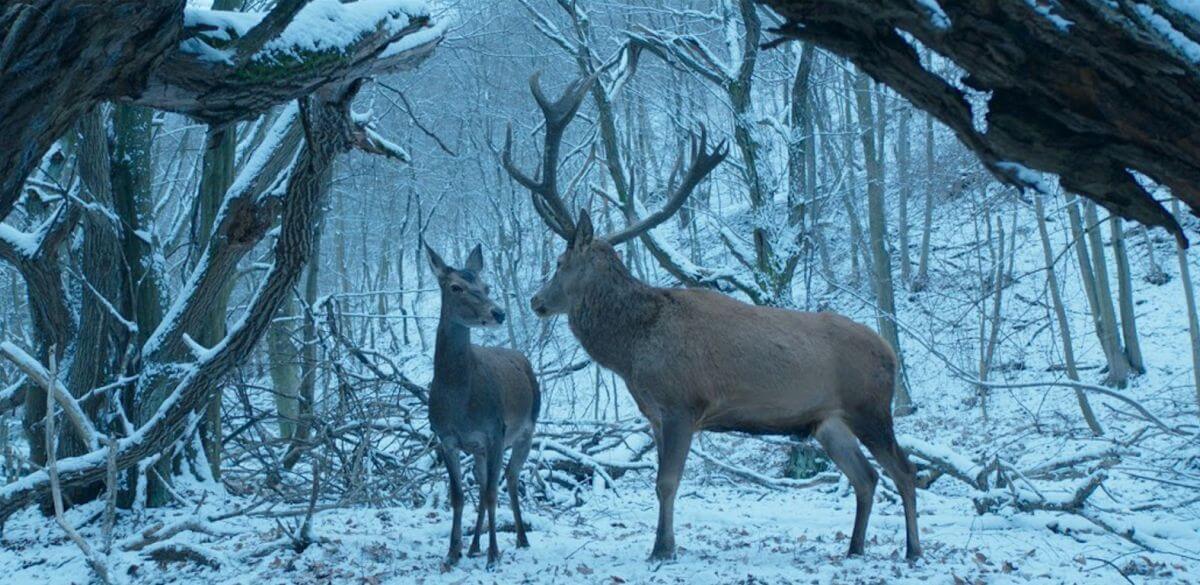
763, 0, 1200, 242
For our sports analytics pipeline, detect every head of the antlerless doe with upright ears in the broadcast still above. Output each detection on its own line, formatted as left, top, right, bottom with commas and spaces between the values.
425, 239, 505, 327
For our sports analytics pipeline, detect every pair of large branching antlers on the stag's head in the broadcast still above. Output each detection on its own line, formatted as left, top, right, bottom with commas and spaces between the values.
500, 72, 730, 246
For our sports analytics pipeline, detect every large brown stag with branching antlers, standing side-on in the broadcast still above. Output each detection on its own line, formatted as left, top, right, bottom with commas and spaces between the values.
502, 76, 920, 560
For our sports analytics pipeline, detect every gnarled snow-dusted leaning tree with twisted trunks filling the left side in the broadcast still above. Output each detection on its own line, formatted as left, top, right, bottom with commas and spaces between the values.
0, 0, 444, 523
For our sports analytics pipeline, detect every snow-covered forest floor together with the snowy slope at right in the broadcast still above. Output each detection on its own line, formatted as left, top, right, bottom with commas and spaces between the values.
0, 203, 1200, 585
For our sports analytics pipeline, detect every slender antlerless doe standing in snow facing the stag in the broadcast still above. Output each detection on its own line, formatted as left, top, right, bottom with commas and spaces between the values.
426, 246, 541, 568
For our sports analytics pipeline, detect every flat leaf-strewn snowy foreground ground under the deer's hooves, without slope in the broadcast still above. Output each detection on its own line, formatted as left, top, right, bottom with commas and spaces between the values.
0, 469, 1200, 585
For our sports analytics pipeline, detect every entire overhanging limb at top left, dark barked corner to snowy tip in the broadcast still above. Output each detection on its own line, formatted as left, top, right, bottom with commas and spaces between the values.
0, 0, 444, 224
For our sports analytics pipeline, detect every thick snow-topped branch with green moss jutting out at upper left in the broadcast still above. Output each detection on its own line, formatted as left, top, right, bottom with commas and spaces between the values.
139, 0, 442, 123
